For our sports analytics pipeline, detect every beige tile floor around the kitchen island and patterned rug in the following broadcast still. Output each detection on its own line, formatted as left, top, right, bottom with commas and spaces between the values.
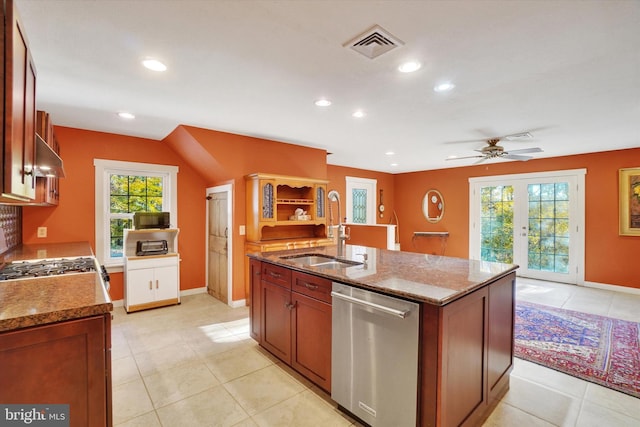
112, 279, 640, 427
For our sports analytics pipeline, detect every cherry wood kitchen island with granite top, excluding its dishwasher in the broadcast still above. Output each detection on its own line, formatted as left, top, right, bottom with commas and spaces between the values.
248, 245, 517, 426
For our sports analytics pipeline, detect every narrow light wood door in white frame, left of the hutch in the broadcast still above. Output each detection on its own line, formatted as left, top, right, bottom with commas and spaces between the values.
207, 191, 229, 304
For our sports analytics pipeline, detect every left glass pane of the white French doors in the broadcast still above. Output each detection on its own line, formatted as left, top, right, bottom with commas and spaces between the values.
480, 185, 513, 263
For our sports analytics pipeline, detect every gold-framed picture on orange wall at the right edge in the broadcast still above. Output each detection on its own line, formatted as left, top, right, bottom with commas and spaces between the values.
618, 168, 640, 236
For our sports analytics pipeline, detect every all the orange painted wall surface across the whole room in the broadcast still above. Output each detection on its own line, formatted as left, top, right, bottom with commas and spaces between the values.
23, 126, 640, 300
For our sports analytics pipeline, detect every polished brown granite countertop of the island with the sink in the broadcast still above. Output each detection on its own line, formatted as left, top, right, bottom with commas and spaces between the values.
247, 245, 518, 305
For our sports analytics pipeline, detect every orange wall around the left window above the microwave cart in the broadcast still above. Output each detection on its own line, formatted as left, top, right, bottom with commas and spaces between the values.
22, 127, 206, 300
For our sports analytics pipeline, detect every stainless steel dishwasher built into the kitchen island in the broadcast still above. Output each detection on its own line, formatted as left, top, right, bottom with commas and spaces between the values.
331, 282, 420, 427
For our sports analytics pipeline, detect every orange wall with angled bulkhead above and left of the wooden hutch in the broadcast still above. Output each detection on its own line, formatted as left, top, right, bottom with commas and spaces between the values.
164, 126, 327, 300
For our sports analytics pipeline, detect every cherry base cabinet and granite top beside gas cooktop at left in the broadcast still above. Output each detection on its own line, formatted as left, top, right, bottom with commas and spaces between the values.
0, 242, 113, 426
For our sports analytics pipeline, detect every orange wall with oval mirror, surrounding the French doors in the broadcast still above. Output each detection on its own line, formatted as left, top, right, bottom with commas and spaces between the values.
394, 148, 640, 288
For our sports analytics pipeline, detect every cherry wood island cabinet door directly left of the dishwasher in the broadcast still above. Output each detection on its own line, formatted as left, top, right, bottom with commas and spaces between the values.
291, 292, 331, 392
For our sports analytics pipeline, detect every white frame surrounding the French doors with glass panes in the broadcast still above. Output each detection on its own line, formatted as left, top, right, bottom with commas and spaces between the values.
469, 169, 587, 285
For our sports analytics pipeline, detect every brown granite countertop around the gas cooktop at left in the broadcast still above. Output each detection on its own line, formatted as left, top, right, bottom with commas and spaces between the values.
0, 242, 113, 332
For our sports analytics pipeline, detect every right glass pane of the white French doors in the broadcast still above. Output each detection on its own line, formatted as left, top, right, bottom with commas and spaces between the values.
527, 182, 569, 273
